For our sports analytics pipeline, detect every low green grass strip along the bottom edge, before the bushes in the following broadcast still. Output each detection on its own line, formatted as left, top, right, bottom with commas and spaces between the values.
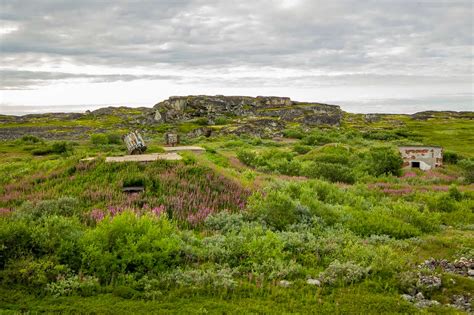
0, 287, 422, 314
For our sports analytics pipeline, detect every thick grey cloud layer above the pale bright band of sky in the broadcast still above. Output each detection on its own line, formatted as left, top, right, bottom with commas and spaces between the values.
1, 0, 472, 70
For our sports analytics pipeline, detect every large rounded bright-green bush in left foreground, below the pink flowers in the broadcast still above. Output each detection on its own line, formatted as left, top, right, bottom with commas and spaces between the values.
81, 212, 182, 282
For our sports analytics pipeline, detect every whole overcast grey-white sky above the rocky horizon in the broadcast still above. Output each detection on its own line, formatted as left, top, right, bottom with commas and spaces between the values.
0, 0, 474, 114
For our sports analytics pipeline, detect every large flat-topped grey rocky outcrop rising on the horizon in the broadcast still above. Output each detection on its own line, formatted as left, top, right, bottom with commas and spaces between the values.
154, 95, 343, 126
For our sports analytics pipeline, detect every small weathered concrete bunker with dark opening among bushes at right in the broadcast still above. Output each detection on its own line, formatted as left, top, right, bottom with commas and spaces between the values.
399, 146, 443, 170
